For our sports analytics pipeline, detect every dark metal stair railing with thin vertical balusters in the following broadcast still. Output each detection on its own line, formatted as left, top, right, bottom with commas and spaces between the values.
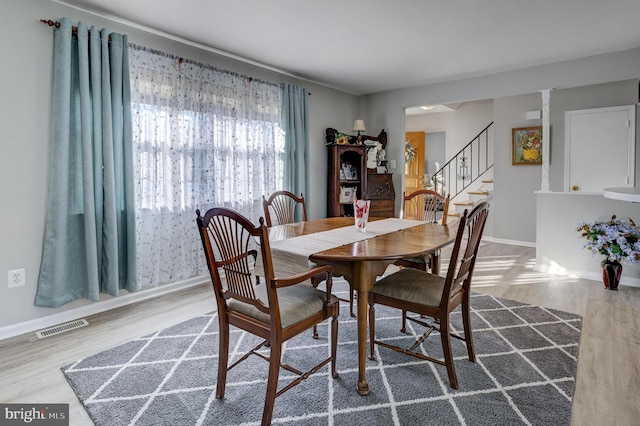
427, 121, 493, 200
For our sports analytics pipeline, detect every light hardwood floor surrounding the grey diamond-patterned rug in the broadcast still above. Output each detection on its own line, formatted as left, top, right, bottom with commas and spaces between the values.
0, 243, 640, 425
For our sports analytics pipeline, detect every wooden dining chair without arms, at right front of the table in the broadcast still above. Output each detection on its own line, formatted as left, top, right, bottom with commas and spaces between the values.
368, 202, 489, 389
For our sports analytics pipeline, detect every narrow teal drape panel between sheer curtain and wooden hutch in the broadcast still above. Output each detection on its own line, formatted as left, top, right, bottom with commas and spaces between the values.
282, 83, 309, 204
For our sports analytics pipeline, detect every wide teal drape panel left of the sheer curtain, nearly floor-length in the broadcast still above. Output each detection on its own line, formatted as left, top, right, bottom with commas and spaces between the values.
35, 18, 138, 307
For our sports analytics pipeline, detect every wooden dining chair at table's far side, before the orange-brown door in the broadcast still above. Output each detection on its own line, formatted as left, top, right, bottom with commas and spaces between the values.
395, 189, 449, 274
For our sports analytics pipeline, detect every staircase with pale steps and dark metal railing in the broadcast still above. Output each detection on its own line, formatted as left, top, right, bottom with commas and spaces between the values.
430, 122, 493, 217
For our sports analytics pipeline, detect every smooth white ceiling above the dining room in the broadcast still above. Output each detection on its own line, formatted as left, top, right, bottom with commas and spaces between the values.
55, 0, 640, 95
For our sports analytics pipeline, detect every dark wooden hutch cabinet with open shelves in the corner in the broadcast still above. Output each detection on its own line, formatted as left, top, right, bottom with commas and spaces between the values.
327, 129, 396, 217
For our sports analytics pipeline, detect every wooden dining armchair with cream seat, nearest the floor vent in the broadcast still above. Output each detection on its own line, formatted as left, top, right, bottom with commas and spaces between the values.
196, 208, 339, 425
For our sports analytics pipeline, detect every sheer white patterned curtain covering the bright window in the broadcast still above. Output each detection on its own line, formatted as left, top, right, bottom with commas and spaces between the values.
130, 45, 285, 287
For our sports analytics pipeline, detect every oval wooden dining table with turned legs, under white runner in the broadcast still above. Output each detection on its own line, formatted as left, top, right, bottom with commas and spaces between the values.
269, 217, 457, 395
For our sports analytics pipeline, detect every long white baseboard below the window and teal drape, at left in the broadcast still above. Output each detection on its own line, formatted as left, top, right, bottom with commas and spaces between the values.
0, 275, 209, 340
